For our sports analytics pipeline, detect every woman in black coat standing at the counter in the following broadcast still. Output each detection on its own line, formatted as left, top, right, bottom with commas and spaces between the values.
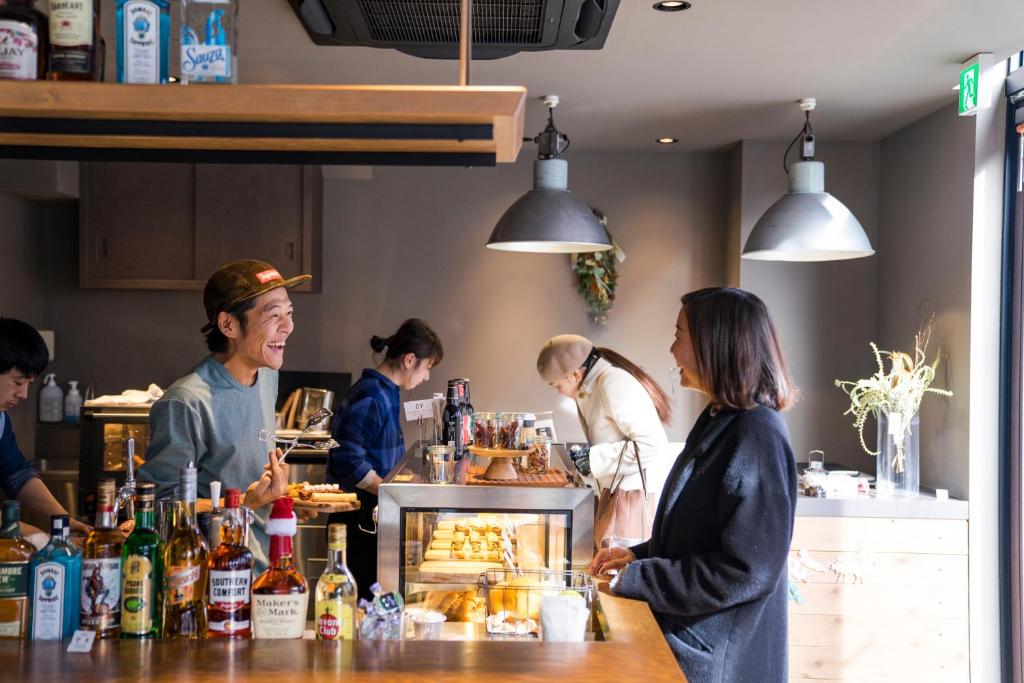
591, 288, 797, 683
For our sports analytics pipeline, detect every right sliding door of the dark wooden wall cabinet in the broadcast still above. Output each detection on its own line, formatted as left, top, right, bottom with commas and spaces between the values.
196, 164, 319, 290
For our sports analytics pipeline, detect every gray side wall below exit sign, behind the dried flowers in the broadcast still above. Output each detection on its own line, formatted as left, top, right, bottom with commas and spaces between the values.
877, 105, 975, 498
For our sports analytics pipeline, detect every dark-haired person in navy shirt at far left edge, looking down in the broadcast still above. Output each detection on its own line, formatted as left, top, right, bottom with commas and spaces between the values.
0, 317, 90, 540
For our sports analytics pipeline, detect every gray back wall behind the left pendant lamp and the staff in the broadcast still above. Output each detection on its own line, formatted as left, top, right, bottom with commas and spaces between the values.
19, 153, 728, 454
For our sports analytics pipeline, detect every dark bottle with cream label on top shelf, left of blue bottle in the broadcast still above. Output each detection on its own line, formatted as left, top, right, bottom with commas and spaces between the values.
46, 0, 100, 81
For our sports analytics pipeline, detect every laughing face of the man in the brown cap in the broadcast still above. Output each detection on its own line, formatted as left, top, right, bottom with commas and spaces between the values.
217, 287, 295, 370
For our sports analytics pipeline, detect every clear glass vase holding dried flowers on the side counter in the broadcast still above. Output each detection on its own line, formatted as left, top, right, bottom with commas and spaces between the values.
874, 413, 921, 498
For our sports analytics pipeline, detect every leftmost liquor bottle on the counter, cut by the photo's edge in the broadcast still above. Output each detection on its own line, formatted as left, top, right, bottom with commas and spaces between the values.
0, 501, 36, 640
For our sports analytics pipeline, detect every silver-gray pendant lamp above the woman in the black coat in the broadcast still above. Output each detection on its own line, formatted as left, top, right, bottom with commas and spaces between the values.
742, 98, 874, 261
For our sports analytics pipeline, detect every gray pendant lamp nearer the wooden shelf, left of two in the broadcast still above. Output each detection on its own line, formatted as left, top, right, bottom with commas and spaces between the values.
487, 95, 611, 254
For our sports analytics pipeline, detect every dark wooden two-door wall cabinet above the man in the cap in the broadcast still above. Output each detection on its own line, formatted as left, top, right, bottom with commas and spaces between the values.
79, 162, 323, 292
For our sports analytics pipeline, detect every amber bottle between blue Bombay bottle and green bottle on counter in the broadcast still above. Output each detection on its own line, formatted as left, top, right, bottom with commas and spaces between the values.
82, 479, 124, 638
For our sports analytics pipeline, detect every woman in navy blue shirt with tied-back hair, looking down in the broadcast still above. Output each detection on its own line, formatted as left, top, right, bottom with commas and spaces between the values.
327, 318, 444, 599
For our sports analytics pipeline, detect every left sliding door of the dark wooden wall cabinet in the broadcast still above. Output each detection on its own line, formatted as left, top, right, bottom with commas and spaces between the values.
79, 162, 195, 289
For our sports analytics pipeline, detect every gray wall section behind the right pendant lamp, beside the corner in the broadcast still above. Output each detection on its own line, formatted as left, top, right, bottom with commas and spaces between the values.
739, 140, 879, 472
